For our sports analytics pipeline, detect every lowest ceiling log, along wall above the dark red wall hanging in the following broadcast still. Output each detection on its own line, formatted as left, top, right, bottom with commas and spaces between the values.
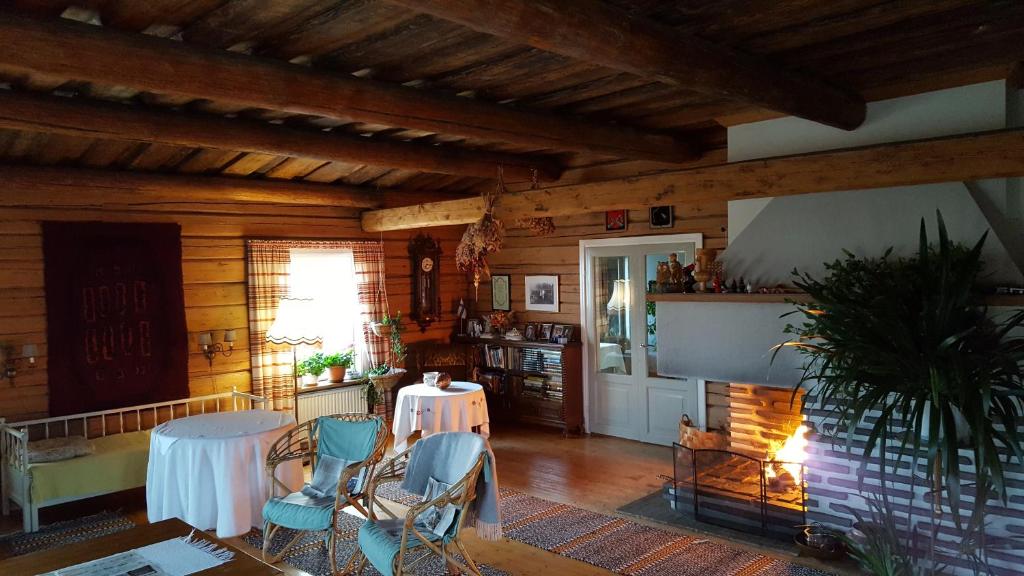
0, 164, 385, 208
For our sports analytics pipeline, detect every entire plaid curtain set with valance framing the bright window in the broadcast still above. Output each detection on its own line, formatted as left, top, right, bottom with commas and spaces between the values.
246, 240, 390, 410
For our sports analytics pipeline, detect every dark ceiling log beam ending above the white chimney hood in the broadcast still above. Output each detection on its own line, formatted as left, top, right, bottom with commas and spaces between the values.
389, 0, 865, 130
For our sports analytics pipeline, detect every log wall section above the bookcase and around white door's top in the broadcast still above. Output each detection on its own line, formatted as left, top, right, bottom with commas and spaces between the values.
469, 195, 728, 325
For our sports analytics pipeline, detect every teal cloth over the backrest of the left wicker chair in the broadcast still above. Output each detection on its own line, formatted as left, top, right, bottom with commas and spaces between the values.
311, 414, 386, 469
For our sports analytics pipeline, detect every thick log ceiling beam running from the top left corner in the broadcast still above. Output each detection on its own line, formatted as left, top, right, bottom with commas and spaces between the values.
0, 12, 697, 162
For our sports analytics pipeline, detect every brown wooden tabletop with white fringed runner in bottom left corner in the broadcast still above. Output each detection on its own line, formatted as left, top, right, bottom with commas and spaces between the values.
0, 519, 282, 576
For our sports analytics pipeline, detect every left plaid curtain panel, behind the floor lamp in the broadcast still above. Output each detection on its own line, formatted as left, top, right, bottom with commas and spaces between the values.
246, 240, 295, 410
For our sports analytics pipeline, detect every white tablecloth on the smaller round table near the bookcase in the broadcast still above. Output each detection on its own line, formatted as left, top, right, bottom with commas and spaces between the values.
391, 381, 490, 452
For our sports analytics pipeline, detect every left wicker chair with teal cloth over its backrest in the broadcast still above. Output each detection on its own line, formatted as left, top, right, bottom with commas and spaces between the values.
263, 414, 390, 574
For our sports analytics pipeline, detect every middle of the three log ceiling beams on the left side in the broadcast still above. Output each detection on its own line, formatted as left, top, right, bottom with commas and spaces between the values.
0, 90, 561, 181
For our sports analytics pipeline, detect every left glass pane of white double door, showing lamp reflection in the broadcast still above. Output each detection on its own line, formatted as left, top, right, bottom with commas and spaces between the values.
593, 256, 634, 375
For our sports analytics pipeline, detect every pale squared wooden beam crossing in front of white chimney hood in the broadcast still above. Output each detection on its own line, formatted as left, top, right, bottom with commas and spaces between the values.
362, 128, 1024, 232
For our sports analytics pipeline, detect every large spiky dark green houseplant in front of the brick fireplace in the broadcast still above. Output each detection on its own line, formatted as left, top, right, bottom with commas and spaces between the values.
775, 214, 1024, 570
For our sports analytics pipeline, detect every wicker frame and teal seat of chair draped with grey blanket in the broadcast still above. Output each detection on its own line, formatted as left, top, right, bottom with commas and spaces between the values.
346, 433, 487, 576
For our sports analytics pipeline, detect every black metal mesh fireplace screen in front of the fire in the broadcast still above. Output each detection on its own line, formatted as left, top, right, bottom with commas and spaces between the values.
670, 444, 806, 539
